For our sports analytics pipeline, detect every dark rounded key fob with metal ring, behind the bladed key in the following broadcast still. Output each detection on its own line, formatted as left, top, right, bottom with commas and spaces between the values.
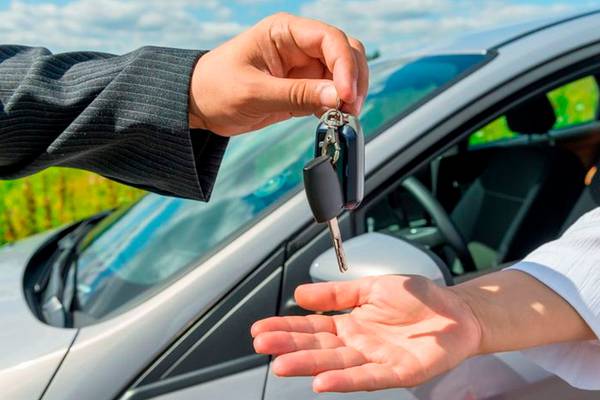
315, 109, 365, 210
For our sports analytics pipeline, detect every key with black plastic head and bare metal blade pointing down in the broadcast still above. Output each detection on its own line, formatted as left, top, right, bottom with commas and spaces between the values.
303, 155, 348, 272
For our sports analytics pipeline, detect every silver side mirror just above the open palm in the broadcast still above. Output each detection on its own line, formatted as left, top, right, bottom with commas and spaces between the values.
310, 232, 452, 286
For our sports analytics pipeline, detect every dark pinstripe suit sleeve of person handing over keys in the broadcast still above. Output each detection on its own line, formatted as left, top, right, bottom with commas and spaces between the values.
0, 45, 227, 200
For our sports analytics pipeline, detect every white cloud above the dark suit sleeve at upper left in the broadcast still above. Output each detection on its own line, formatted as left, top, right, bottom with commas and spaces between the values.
0, 0, 245, 53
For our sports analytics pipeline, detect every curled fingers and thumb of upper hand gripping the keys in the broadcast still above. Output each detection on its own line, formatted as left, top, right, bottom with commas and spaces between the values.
252, 14, 369, 115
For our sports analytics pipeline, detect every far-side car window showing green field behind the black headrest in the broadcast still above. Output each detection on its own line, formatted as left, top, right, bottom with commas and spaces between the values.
469, 76, 599, 147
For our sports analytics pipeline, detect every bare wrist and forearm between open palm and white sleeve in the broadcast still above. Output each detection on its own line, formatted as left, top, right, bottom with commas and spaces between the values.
450, 270, 595, 354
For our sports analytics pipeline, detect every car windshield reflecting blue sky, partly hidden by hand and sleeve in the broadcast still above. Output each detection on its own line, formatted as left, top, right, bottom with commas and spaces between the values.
70, 55, 484, 318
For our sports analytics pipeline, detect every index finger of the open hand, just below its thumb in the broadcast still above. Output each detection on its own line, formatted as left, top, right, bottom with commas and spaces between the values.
250, 315, 336, 337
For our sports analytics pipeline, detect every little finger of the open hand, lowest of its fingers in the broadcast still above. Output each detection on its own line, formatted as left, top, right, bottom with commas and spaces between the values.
313, 363, 402, 393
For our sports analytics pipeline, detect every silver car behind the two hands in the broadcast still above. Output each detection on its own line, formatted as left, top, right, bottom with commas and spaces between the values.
0, 11, 600, 400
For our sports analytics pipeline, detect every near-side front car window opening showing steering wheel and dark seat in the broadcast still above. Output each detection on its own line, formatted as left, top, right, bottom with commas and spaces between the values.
357, 76, 598, 278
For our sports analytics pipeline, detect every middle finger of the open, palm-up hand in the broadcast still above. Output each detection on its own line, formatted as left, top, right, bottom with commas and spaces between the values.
254, 331, 344, 355
